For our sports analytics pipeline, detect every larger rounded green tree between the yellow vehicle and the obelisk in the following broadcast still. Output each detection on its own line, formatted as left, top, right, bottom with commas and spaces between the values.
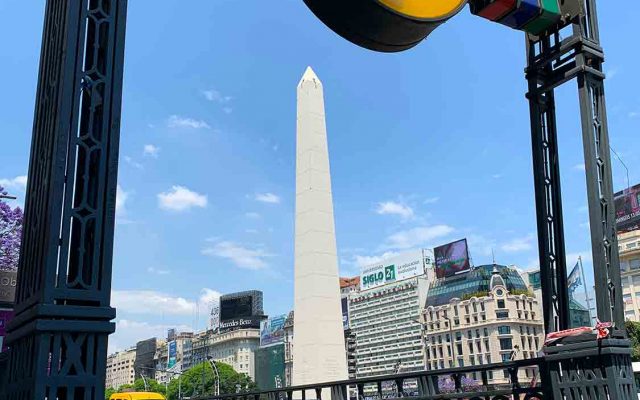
167, 362, 258, 400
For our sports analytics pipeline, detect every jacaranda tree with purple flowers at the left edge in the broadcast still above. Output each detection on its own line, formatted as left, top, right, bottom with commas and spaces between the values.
0, 186, 23, 271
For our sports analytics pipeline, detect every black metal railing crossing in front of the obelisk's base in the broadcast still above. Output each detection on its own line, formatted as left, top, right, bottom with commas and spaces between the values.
200, 358, 552, 400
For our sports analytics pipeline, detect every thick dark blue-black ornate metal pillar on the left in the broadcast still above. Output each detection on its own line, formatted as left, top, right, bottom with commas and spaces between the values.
0, 0, 127, 400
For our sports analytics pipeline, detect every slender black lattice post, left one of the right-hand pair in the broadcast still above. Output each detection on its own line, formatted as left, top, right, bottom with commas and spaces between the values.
527, 38, 569, 332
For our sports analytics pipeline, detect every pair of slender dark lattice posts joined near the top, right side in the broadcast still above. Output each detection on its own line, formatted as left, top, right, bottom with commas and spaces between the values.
526, 0, 624, 332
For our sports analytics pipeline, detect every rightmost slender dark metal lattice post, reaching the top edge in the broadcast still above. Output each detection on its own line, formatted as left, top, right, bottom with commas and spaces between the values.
574, 0, 624, 329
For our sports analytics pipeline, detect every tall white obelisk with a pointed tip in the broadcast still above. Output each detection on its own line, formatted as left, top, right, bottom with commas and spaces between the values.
292, 67, 348, 388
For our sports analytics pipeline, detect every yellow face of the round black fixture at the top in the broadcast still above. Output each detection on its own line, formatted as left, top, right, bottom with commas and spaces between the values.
378, 0, 467, 21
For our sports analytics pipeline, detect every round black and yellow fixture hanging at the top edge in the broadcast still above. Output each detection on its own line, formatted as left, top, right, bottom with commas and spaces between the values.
304, 0, 467, 52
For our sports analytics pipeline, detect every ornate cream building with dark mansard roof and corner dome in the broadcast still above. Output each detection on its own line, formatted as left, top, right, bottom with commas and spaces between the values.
422, 265, 544, 384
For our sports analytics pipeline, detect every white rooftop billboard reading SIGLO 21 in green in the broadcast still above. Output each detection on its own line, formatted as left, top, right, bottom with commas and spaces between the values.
360, 250, 424, 290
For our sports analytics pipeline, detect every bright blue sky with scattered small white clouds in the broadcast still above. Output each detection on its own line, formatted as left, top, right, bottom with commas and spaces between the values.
0, 0, 640, 350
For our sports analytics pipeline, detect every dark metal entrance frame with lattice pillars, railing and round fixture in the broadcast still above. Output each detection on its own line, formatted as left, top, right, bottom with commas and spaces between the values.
0, 0, 637, 400
